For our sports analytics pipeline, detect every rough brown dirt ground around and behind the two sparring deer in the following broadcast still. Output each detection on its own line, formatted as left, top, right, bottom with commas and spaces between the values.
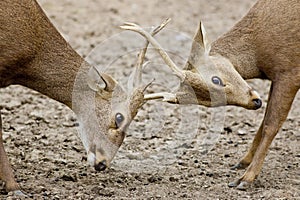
0, 0, 300, 199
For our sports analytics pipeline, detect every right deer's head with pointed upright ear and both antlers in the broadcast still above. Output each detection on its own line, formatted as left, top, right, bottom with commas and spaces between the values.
122, 22, 262, 109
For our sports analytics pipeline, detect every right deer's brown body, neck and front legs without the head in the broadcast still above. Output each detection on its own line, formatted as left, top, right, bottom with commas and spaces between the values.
210, 0, 300, 189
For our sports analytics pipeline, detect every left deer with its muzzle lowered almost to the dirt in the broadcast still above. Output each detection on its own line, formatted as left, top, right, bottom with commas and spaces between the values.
0, 0, 169, 196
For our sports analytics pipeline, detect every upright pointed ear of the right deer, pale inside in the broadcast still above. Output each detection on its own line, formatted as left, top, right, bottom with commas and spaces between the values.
186, 21, 210, 70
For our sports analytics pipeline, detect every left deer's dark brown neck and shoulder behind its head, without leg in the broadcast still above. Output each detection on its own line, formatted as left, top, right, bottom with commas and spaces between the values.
0, 0, 79, 106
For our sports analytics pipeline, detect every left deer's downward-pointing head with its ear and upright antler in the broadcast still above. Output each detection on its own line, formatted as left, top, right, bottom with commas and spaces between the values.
72, 20, 169, 171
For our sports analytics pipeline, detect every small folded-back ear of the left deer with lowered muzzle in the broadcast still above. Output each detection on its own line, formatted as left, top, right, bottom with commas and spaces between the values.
87, 67, 117, 92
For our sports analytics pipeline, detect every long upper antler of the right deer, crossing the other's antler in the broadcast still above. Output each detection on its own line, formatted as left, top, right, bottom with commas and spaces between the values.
120, 20, 185, 81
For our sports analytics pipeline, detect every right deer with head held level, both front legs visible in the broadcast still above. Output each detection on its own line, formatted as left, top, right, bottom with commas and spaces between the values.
122, 0, 300, 190
